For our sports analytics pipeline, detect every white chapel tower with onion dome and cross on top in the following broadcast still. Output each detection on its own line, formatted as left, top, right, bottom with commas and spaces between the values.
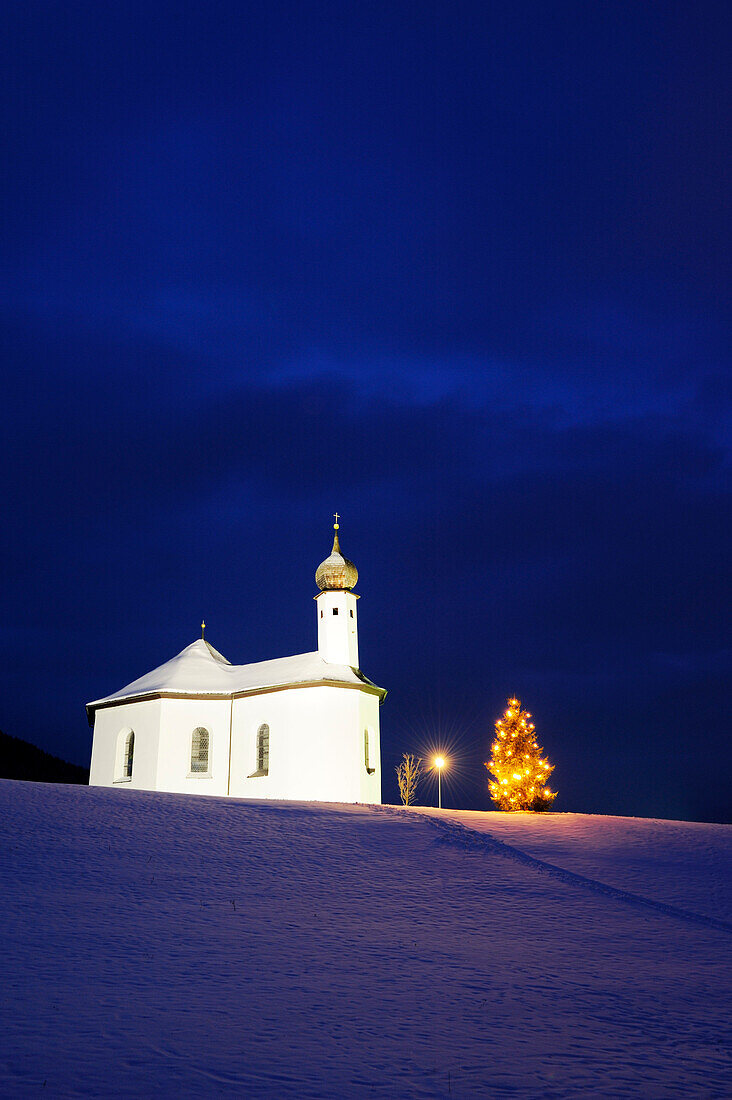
315, 513, 359, 669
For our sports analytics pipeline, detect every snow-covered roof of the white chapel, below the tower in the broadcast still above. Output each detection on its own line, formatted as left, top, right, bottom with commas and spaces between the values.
87, 638, 386, 714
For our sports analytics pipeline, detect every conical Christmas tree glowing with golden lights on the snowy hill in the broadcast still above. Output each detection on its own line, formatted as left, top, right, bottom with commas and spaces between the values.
485, 699, 557, 810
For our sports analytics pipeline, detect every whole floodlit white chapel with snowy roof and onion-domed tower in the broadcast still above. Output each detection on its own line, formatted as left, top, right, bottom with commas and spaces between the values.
87, 516, 386, 803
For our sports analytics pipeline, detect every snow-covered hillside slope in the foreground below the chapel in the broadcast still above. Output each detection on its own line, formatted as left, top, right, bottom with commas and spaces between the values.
0, 781, 732, 1098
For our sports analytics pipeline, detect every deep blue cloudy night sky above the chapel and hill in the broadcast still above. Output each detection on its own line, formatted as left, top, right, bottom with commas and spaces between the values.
0, 0, 732, 820
